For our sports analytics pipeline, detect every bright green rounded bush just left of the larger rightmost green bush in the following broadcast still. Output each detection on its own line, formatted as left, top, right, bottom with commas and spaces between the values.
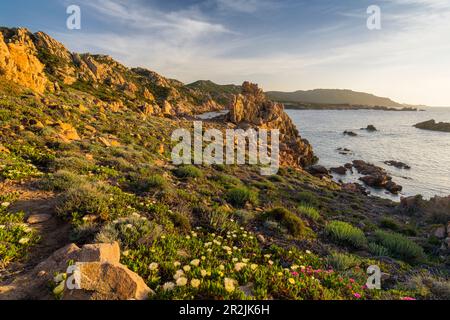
325, 221, 367, 248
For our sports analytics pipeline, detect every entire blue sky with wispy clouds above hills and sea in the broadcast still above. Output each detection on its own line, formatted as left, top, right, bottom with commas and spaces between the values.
0, 0, 450, 106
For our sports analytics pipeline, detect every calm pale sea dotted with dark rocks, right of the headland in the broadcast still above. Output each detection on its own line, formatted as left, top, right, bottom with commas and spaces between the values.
286, 108, 450, 200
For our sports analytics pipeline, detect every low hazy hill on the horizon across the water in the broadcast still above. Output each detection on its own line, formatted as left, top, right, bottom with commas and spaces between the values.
267, 89, 404, 108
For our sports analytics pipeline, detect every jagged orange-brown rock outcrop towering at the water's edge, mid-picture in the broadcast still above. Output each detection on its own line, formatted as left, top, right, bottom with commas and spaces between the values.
227, 82, 316, 167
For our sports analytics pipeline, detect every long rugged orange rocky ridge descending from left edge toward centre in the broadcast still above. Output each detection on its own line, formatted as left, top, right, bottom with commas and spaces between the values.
0, 28, 232, 116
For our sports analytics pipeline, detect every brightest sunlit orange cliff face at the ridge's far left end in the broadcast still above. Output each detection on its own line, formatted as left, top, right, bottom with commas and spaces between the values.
0, 28, 49, 93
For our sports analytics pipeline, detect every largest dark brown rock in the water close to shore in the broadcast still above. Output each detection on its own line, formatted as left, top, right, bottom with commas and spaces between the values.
353, 160, 403, 194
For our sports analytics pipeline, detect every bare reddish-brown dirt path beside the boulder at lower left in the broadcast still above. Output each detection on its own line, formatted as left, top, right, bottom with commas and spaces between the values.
0, 181, 70, 287
